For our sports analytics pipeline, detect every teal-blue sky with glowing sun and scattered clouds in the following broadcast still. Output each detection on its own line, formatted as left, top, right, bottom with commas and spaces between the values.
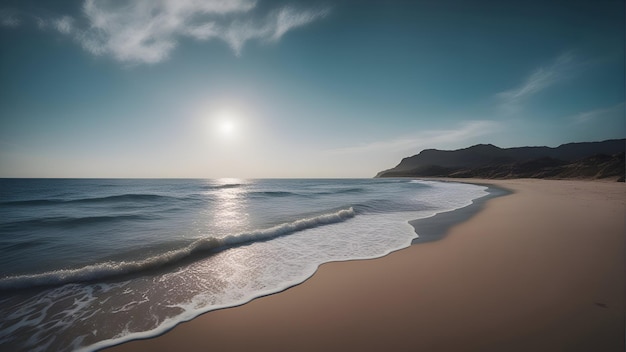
0, 0, 626, 178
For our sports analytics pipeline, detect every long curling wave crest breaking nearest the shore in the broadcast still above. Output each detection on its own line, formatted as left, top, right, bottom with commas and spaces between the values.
0, 208, 355, 290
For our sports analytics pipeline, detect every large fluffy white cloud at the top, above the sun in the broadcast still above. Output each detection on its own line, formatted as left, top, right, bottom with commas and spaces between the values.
0, 0, 330, 64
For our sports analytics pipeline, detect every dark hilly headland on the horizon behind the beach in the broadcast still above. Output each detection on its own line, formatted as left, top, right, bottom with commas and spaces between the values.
376, 139, 626, 182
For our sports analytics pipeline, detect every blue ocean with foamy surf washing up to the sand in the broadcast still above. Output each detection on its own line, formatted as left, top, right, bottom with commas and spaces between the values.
0, 179, 488, 351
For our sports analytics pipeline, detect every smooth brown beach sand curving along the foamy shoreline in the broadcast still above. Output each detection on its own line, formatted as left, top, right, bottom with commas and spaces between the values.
105, 180, 626, 351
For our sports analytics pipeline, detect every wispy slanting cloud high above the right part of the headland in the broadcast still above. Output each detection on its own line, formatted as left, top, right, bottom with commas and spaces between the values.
496, 52, 574, 112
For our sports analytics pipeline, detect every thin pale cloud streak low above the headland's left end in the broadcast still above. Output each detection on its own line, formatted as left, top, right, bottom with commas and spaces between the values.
330, 120, 500, 154
